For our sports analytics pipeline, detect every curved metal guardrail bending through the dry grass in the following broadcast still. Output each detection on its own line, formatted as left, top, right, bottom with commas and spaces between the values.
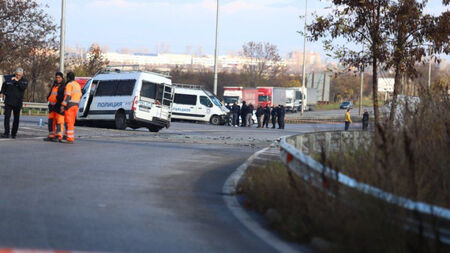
280, 131, 450, 244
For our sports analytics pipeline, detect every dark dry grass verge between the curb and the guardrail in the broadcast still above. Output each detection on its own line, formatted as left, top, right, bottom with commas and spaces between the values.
241, 162, 449, 252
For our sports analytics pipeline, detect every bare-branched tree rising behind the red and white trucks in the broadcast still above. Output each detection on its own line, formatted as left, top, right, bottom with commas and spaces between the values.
242, 41, 281, 85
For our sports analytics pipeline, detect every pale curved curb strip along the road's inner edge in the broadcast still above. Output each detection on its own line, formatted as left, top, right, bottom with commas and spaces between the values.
222, 144, 311, 253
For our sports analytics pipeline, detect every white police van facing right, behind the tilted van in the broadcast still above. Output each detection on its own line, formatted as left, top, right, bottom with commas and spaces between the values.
172, 84, 229, 125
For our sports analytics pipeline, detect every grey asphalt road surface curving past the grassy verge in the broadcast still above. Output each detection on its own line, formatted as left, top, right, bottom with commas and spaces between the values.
0, 117, 342, 252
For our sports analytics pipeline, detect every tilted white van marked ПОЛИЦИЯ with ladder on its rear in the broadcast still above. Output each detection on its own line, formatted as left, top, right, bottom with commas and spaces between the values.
77, 72, 174, 132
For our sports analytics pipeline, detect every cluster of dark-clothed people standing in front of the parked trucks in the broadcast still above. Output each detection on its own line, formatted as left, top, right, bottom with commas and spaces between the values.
226, 101, 286, 129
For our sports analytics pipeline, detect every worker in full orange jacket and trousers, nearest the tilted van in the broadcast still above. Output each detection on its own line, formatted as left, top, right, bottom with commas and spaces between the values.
61, 72, 82, 144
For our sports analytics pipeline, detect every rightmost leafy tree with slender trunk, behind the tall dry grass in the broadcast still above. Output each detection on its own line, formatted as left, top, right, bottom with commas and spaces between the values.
385, 0, 450, 128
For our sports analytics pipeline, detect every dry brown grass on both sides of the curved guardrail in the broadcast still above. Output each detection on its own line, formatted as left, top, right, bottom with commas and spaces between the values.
241, 88, 450, 252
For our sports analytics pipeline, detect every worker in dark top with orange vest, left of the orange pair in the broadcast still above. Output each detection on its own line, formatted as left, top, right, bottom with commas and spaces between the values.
44, 72, 65, 141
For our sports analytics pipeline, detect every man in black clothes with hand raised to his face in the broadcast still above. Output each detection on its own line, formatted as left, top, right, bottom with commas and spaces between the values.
0, 68, 28, 139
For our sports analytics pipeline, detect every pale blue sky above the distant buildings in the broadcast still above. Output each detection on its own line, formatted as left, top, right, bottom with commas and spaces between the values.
37, 0, 442, 59
